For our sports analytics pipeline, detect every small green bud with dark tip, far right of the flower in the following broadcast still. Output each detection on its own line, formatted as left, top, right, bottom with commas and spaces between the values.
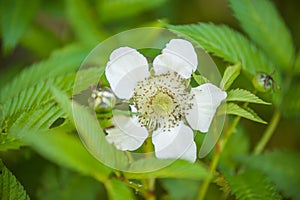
252, 71, 280, 92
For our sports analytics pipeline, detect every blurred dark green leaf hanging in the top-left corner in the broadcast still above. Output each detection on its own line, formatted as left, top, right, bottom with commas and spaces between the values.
0, 0, 39, 53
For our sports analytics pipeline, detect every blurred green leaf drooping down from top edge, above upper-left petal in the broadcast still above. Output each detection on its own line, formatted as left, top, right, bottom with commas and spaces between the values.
65, 0, 107, 45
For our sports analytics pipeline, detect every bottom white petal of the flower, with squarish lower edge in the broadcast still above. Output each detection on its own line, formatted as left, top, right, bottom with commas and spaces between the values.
152, 123, 196, 162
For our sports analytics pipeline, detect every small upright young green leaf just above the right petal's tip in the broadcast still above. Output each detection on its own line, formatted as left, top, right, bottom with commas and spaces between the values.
220, 63, 241, 90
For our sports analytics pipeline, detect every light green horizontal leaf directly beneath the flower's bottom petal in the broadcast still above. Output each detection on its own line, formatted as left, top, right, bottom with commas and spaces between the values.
125, 158, 209, 180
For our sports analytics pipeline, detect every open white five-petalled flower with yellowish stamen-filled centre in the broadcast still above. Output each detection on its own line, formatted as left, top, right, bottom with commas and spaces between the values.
105, 39, 226, 162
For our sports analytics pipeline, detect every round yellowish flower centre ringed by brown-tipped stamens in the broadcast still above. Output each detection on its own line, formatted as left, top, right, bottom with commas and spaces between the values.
132, 72, 193, 131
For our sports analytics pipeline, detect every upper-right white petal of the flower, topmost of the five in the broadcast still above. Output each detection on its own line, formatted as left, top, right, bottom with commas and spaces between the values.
153, 39, 198, 78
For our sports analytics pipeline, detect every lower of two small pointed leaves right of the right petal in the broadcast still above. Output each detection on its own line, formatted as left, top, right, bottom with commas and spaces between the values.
226, 103, 267, 124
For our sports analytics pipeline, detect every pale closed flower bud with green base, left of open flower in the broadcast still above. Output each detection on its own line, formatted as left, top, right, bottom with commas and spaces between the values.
88, 84, 116, 129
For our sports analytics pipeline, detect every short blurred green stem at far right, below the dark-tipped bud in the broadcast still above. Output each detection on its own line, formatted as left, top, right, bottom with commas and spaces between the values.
254, 109, 281, 155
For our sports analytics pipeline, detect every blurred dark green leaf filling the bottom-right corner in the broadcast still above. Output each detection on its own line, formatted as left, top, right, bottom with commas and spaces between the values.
237, 151, 300, 199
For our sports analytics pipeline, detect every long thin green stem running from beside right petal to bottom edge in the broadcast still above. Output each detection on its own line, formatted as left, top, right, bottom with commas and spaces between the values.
197, 116, 241, 200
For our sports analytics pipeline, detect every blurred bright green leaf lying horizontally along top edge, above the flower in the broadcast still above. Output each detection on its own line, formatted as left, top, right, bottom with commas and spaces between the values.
98, 0, 166, 22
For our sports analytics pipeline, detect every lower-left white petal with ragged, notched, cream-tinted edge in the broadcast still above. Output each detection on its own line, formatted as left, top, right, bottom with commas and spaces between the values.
106, 115, 148, 151
